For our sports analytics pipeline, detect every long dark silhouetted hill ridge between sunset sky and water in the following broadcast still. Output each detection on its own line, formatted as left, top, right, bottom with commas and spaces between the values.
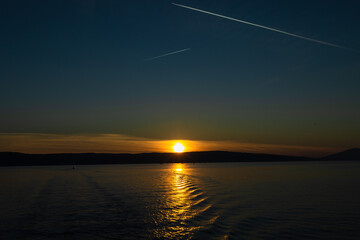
0, 148, 360, 166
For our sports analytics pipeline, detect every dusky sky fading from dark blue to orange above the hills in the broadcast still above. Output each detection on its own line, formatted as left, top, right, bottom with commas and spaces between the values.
0, 0, 360, 156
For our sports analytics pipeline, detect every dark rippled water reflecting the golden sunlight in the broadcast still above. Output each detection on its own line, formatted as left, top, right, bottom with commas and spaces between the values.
0, 162, 360, 239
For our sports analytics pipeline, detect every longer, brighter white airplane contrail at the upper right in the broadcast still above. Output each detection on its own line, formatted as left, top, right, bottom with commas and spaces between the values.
172, 3, 354, 51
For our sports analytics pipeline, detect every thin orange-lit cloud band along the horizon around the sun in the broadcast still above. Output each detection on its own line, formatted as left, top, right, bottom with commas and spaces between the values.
0, 133, 340, 156
